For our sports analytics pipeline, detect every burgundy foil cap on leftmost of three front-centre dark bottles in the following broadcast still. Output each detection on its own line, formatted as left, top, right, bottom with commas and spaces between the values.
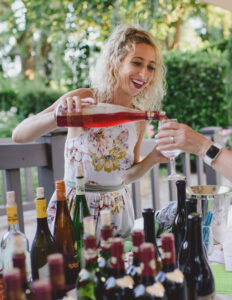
111, 238, 125, 270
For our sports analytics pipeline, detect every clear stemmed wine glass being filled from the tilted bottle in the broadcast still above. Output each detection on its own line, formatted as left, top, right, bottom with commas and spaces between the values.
158, 119, 185, 180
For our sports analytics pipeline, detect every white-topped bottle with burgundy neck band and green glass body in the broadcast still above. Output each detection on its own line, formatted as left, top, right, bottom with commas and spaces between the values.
76, 217, 99, 300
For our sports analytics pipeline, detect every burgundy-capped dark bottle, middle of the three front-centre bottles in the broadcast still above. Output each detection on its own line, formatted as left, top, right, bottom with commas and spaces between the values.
134, 243, 166, 300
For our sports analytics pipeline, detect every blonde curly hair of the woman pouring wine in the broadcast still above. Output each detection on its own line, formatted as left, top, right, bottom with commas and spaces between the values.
91, 24, 166, 110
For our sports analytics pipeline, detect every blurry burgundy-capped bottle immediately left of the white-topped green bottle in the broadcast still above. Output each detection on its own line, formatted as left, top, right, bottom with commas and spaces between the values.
47, 253, 66, 300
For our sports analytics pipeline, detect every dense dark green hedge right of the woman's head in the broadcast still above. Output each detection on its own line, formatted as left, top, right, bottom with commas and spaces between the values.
163, 51, 228, 130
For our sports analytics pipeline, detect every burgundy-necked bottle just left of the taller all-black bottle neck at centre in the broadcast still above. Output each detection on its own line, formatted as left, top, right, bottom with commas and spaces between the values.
126, 230, 144, 286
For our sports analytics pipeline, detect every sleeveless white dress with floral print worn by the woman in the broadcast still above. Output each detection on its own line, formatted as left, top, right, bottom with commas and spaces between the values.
48, 123, 138, 238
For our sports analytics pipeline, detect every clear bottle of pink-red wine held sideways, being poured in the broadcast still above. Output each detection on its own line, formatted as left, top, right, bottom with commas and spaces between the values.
55, 103, 166, 128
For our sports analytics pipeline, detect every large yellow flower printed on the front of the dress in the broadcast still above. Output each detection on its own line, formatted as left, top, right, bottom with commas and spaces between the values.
90, 139, 127, 173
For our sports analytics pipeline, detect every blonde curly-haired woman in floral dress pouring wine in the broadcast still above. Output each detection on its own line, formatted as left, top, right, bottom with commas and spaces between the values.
12, 25, 167, 237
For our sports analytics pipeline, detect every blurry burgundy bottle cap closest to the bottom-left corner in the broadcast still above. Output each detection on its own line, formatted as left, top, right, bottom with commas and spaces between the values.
3, 268, 22, 292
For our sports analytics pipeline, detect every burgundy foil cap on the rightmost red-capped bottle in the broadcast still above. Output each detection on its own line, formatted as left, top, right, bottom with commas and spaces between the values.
161, 233, 176, 264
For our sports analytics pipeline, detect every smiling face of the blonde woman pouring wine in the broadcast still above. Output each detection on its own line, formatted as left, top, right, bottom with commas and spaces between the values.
117, 43, 155, 105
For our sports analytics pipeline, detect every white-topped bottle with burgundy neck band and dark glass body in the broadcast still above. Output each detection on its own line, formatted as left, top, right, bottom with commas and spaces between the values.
98, 209, 113, 276
